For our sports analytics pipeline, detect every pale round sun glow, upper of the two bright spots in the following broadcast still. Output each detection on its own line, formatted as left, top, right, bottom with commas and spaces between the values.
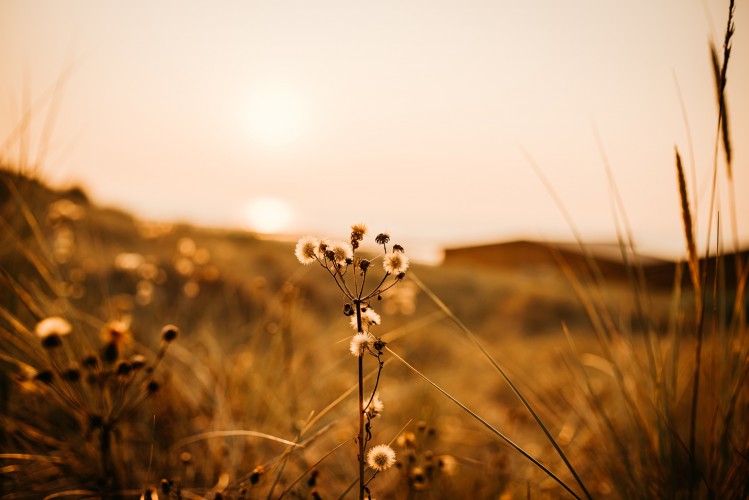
240, 90, 305, 146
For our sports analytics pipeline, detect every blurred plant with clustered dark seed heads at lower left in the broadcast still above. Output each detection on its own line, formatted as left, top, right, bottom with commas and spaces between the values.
0, 308, 179, 498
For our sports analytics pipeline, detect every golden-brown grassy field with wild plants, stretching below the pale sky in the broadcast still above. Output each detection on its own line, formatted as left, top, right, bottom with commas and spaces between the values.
0, 1, 749, 499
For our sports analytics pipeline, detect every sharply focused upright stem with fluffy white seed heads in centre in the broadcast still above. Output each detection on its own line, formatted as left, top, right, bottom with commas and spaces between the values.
295, 224, 409, 499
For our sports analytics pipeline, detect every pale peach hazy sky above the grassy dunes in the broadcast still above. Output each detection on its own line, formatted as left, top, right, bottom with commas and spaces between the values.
0, 0, 749, 261
